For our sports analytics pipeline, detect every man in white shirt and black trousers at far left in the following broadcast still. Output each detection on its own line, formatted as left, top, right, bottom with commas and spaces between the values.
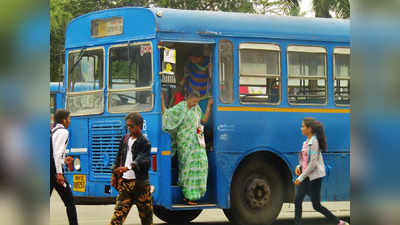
50, 109, 78, 225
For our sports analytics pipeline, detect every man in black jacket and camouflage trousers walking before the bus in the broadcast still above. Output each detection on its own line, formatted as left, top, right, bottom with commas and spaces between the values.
110, 113, 153, 225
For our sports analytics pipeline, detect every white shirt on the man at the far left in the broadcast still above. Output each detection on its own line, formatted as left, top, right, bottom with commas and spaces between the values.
51, 123, 69, 173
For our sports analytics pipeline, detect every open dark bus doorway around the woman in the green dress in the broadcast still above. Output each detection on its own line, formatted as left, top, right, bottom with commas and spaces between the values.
159, 42, 216, 206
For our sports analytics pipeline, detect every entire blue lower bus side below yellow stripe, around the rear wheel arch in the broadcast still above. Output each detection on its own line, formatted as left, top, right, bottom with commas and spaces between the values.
215, 110, 350, 208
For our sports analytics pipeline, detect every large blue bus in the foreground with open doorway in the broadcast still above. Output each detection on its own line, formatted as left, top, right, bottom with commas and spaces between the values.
59, 7, 351, 225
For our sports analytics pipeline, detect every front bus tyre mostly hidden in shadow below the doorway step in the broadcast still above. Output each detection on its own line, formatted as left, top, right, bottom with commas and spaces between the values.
154, 205, 202, 225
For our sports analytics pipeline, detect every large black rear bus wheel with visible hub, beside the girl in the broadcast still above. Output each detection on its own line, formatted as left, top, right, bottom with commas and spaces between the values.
228, 157, 284, 225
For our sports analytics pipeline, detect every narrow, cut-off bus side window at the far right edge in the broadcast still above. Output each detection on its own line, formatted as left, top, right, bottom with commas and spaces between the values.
333, 48, 350, 105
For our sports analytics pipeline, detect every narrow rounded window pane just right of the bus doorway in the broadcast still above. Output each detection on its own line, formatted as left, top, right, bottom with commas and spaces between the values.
218, 40, 233, 103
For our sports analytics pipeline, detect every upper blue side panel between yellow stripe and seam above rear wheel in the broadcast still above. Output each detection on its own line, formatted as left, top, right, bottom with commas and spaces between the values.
215, 108, 350, 156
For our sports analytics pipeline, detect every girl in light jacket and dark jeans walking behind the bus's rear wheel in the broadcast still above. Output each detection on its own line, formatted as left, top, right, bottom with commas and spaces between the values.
294, 118, 348, 225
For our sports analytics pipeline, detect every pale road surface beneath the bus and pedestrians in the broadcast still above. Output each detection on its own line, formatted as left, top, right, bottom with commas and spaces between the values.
50, 192, 350, 225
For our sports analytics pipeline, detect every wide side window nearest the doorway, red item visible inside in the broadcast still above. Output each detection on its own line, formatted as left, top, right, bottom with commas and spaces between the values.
239, 43, 281, 104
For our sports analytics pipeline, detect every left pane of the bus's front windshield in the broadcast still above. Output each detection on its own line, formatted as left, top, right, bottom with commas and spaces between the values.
67, 49, 104, 116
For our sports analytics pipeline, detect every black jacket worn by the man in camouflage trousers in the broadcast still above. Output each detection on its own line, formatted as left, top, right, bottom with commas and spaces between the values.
111, 134, 151, 180
